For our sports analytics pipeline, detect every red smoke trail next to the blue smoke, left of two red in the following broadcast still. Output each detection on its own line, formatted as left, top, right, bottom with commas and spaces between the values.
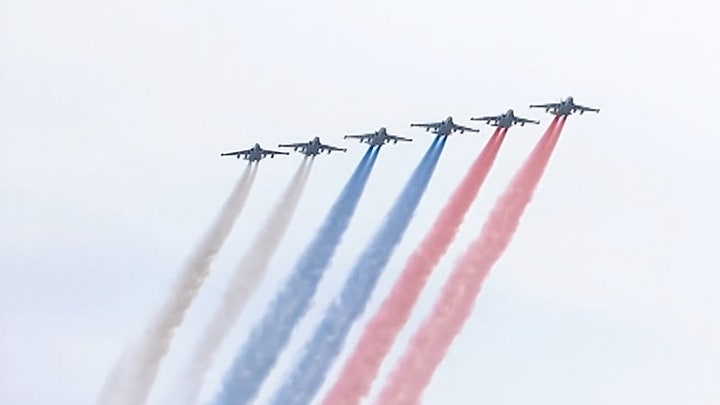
323, 128, 507, 405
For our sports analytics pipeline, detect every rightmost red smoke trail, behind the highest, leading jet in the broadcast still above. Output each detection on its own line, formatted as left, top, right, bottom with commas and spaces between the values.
377, 116, 565, 405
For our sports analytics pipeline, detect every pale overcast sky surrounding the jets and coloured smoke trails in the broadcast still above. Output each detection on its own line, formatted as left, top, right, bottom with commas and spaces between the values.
0, 0, 720, 405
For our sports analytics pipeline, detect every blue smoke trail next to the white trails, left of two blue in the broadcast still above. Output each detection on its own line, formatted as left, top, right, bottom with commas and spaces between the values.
215, 147, 379, 404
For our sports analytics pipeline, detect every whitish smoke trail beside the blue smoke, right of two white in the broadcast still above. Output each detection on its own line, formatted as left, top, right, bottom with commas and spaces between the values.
174, 157, 313, 405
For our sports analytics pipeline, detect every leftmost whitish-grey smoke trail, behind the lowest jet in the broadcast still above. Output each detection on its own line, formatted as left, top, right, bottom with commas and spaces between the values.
98, 164, 257, 405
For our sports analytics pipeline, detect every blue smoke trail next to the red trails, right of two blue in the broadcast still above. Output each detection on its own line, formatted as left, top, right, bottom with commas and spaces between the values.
271, 136, 447, 405
